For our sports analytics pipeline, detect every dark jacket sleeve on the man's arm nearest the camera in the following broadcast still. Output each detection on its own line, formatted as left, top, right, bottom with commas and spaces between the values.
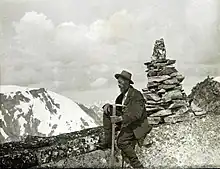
122, 93, 145, 126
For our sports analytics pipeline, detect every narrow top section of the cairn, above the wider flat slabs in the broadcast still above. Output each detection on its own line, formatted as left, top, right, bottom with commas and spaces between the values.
152, 38, 166, 60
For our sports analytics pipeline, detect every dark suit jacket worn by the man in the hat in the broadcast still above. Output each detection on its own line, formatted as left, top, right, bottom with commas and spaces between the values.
115, 86, 152, 140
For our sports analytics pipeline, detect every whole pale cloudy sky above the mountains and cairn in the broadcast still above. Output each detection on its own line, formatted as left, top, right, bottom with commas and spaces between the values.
0, 0, 220, 102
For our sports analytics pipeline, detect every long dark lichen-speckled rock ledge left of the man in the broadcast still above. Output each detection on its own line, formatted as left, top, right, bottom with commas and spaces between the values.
0, 127, 103, 168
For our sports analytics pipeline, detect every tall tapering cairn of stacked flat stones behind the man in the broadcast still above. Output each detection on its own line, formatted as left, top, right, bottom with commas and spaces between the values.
142, 39, 189, 124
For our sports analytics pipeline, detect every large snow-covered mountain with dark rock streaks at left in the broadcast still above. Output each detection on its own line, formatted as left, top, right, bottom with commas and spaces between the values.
0, 85, 97, 142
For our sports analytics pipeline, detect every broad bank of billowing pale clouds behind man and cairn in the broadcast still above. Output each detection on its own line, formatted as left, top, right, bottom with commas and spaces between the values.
1, 0, 220, 92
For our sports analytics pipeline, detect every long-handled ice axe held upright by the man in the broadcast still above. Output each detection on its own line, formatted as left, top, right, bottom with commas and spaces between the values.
110, 104, 126, 168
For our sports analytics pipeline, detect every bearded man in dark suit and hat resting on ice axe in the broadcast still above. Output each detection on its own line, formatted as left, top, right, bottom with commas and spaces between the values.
97, 70, 152, 168
